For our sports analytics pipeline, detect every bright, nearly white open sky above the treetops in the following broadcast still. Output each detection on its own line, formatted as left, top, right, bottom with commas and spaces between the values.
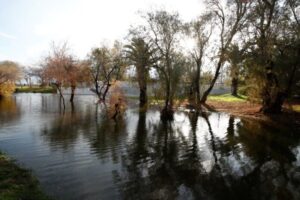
0, 0, 203, 66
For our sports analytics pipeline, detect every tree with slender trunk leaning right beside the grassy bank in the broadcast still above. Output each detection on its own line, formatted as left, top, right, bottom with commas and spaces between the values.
201, 0, 250, 103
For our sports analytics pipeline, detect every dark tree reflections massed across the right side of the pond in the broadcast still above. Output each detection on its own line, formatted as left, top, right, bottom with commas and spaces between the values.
113, 113, 300, 199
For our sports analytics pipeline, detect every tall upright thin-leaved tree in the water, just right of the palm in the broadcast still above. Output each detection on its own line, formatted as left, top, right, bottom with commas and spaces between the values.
145, 10, 182, 118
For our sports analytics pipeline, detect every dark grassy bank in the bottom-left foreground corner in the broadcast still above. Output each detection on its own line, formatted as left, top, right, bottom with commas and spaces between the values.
0, 152, 50, 200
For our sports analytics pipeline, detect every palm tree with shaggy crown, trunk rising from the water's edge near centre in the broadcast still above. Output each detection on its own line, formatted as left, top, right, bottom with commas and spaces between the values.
125, 37, 156, 107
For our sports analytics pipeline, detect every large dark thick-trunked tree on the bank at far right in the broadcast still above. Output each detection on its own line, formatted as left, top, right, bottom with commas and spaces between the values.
245, 0, 300, 114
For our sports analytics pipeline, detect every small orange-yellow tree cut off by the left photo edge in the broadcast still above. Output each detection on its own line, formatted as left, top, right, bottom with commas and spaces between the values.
0, 61, 21, 96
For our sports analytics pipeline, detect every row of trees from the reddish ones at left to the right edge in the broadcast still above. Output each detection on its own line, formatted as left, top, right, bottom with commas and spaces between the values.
1, 0, 300, 117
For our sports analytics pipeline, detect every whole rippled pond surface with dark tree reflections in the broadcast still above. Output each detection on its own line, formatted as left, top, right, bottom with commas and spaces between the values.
0, 94, 300, 199
